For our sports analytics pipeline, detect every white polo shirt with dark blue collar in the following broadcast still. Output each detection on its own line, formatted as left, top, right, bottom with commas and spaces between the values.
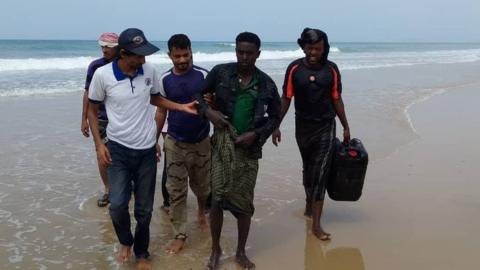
88, 60, 160, 149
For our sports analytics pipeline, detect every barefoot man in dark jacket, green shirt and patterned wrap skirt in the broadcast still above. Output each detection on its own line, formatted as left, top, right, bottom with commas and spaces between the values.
196, 32, 280, 269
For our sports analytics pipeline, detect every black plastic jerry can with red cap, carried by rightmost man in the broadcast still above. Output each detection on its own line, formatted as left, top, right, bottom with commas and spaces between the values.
327, 138, 368, 201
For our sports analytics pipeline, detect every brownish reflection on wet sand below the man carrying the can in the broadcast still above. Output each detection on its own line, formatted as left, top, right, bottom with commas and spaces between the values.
304, 220, 365, 270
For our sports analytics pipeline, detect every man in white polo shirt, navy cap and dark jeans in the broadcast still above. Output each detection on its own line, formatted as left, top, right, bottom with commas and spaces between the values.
88, 28, 196, 269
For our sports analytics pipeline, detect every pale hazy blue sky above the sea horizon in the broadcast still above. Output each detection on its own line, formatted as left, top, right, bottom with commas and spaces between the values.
0, 0, 480, 42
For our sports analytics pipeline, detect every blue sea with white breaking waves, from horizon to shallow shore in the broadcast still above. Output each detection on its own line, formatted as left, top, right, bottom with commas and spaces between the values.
0, 40, 480, 98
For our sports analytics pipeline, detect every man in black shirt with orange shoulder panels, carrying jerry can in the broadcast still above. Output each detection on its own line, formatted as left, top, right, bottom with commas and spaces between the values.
272, 28, 350, 240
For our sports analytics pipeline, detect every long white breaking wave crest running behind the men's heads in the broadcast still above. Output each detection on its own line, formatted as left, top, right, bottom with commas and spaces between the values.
0, 47, 480, 72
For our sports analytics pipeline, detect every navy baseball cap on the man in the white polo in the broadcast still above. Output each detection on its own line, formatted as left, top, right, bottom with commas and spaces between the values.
118, 28, 160, 56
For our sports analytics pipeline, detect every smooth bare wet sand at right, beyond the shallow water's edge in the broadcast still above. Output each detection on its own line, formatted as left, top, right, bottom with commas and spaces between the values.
249, 84, 480, 270
